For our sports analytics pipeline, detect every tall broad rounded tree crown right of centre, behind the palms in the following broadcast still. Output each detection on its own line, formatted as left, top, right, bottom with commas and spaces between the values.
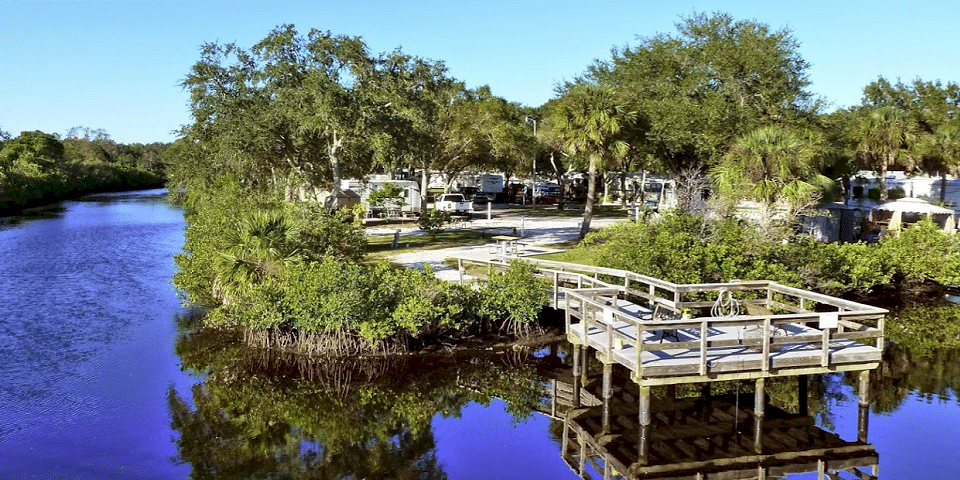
585, 13, 819, 174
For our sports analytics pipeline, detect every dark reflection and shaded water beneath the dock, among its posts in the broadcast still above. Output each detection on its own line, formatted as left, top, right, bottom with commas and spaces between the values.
541, 365, 879, 480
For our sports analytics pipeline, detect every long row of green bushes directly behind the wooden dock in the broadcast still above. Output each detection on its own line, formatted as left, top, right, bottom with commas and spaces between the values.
571, 213, 916, 295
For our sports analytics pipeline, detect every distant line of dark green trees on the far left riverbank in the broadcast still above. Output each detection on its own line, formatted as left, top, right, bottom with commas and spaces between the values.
0, 127, 169, 212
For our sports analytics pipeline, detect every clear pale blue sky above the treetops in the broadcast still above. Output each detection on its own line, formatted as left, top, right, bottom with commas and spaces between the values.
0, 0, 960, 143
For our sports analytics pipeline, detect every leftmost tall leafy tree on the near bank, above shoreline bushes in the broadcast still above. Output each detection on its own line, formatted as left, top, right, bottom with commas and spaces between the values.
179, 25, 383, 207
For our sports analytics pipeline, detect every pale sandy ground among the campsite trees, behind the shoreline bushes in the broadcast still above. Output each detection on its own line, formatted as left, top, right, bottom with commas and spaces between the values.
367, 206, 626, 281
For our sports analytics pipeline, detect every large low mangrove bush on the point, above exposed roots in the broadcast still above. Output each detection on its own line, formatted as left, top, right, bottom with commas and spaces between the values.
211, 257, 477, 350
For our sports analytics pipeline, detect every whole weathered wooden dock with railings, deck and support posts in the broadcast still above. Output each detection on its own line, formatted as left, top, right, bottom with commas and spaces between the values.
458, 258, 887, 479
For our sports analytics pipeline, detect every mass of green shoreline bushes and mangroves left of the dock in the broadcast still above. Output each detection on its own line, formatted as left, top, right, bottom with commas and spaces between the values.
174, 196, 549, 356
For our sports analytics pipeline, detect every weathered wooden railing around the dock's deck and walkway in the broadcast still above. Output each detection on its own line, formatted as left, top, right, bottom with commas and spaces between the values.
458, 258, 887, 384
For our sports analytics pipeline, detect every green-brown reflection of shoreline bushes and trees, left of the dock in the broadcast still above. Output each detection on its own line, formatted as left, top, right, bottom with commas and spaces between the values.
168, 330, 559, 479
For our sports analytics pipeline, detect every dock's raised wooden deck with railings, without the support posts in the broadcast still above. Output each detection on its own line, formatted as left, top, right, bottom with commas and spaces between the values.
459, 259, 886, 385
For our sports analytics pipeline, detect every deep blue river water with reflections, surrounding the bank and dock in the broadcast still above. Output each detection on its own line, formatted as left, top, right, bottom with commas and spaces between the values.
0, 191, 960, 479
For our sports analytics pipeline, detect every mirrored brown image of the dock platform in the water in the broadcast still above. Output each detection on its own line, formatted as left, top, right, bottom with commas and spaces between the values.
561, 395, 879, 480
